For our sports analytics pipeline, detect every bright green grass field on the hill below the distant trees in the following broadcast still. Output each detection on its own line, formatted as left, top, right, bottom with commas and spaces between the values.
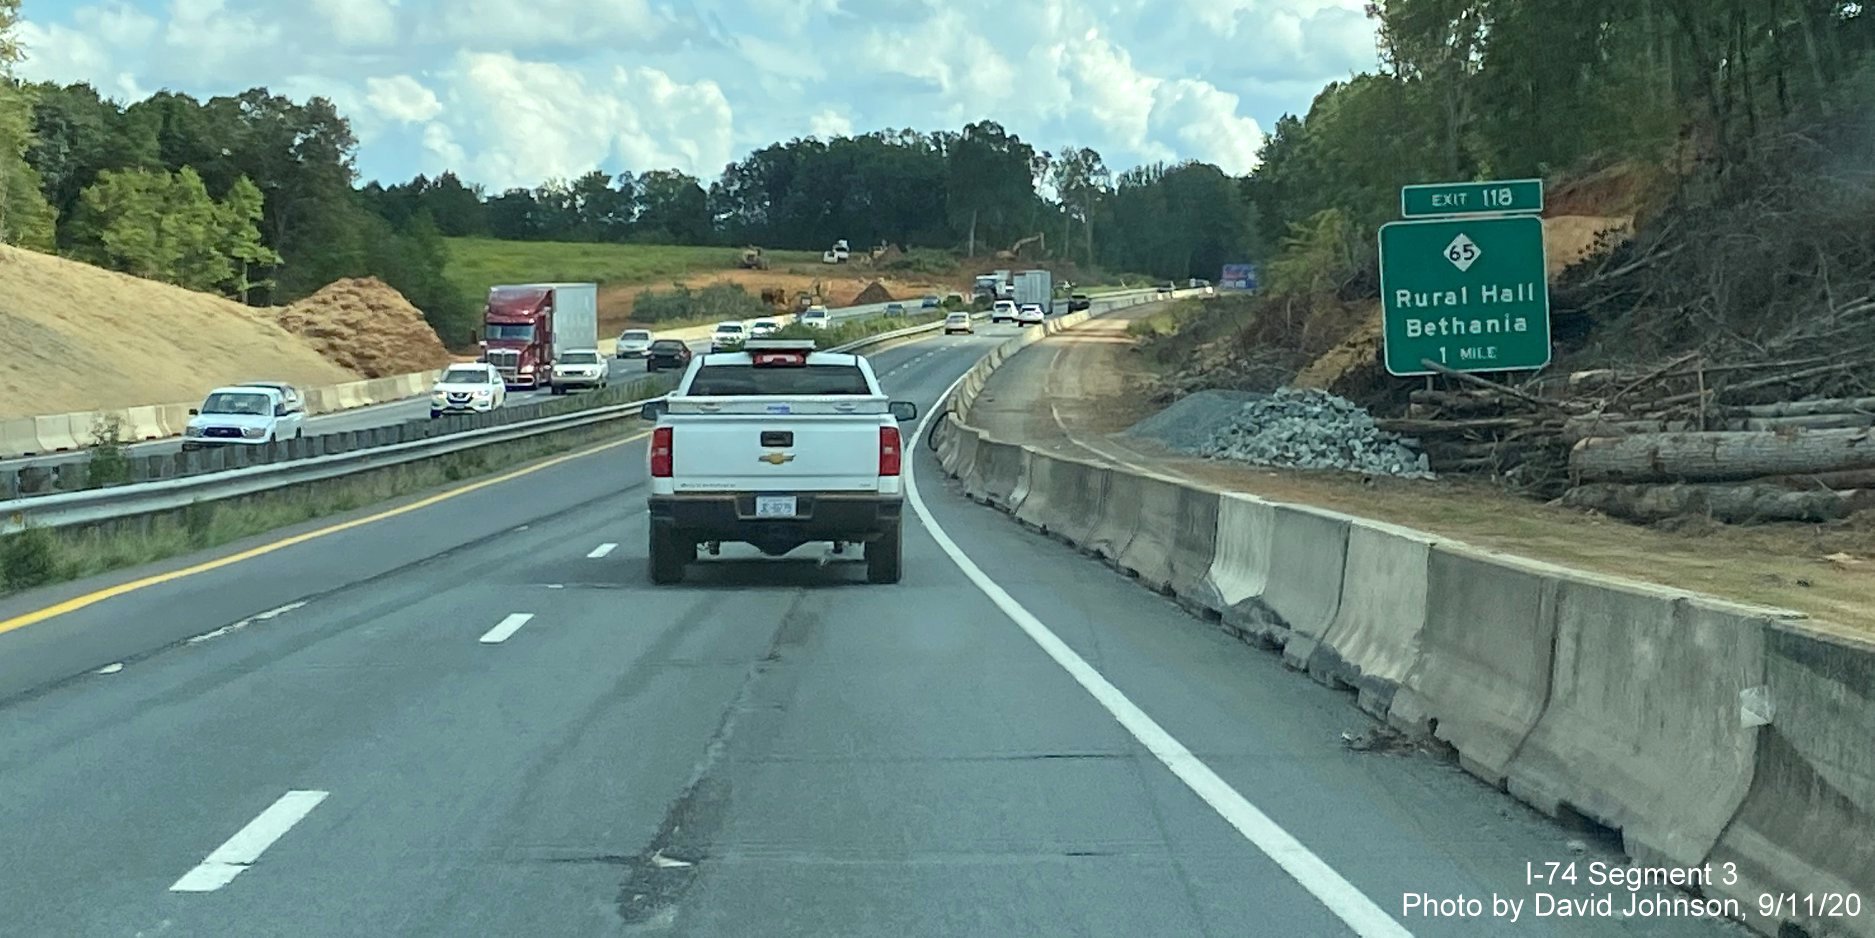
444, 238, 819, 306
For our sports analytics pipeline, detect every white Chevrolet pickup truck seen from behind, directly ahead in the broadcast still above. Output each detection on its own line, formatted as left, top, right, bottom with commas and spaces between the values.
643, 340, 917, 583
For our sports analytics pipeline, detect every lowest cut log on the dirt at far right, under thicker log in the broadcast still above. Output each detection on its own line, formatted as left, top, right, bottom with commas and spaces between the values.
1562, 484, 1875, 523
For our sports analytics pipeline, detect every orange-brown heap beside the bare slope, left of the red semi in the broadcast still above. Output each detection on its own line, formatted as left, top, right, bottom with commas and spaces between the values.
279, 278, 452, 377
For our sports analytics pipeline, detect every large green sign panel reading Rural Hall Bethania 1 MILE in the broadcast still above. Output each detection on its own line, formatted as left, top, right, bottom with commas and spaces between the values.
1380, 216, 1549, 375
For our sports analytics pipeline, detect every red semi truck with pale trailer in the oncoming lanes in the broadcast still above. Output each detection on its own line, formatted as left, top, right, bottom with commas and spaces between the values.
482, 283, 598, 388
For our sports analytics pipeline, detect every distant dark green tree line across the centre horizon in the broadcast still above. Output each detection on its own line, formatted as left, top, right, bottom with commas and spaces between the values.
362, 120, 1256, 285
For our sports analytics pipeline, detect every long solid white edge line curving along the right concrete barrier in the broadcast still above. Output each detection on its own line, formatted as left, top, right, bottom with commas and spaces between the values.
906, 377, 1412, 938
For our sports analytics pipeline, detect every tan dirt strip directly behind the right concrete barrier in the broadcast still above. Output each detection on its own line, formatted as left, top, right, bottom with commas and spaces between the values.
969, 306, 1875, 636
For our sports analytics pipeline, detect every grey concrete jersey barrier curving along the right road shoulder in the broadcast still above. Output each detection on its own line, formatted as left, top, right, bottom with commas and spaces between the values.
938, 292, 1875, 938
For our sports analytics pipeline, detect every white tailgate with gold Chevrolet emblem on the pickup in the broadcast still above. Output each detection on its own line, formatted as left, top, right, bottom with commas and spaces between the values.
666, 415, 891, 492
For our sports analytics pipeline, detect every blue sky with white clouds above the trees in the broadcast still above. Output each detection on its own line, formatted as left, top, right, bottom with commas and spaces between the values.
19, 0, 1374, 189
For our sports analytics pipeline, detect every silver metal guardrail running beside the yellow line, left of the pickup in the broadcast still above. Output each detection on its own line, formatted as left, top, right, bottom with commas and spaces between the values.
0, 307, 1042, 535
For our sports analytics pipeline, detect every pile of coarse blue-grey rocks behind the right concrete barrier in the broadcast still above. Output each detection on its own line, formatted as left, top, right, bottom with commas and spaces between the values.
1196, 388, 1433, 478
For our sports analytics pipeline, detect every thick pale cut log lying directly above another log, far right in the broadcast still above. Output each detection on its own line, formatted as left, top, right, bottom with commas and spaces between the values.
1569, 430, 1875, 482
